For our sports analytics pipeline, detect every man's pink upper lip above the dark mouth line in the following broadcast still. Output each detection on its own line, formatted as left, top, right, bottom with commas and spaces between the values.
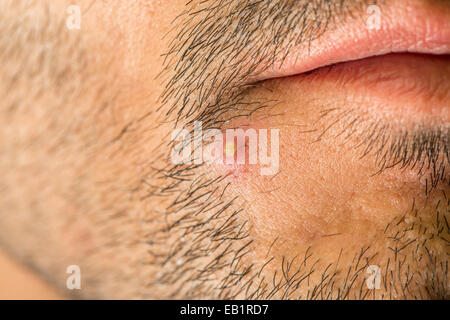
254, 4, 450, 81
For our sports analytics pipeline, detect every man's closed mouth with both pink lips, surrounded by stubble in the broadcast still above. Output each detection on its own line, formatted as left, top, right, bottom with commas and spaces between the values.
255, 4, 450, 125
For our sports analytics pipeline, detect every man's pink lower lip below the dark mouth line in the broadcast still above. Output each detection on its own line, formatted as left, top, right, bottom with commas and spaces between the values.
282, 54, 450, 124
